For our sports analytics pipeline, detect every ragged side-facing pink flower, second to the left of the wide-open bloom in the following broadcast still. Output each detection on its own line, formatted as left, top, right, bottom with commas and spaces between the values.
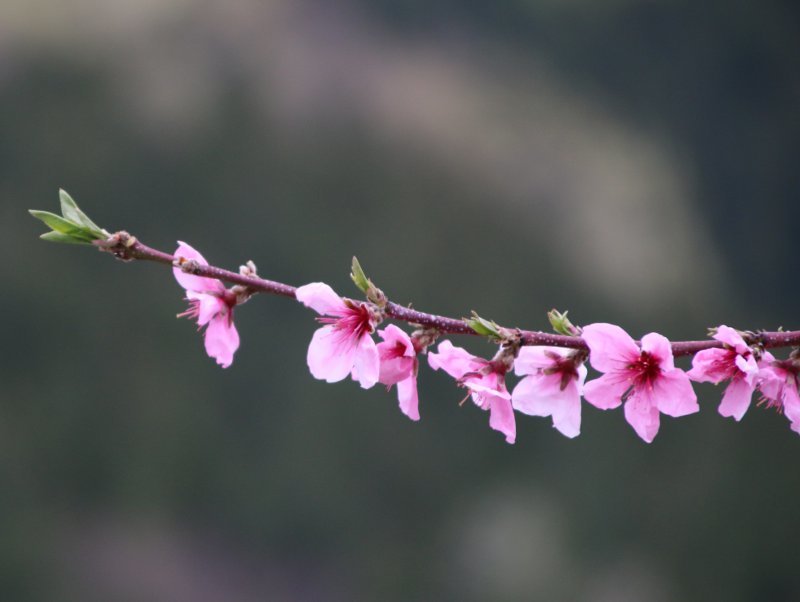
428, 341, 517, 443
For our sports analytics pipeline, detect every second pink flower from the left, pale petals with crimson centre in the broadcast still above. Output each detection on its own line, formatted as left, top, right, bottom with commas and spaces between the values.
295, 282, 380, 389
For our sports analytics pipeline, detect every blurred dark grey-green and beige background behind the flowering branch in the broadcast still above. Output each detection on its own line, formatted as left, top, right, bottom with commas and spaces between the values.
0, 0, 800, 602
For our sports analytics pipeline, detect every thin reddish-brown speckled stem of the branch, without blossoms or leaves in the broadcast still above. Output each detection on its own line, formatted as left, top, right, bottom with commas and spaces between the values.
100, 232, 800, 356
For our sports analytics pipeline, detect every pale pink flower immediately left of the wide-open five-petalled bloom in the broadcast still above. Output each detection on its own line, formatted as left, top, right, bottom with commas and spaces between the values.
511, 347, 586, 437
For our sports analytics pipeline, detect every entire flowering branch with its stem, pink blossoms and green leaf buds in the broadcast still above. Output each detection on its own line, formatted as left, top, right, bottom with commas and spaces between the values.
30, 195, 800, 443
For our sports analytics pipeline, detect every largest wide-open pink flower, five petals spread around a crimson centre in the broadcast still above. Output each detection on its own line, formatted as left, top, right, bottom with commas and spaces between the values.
582, 323, 700, 443
